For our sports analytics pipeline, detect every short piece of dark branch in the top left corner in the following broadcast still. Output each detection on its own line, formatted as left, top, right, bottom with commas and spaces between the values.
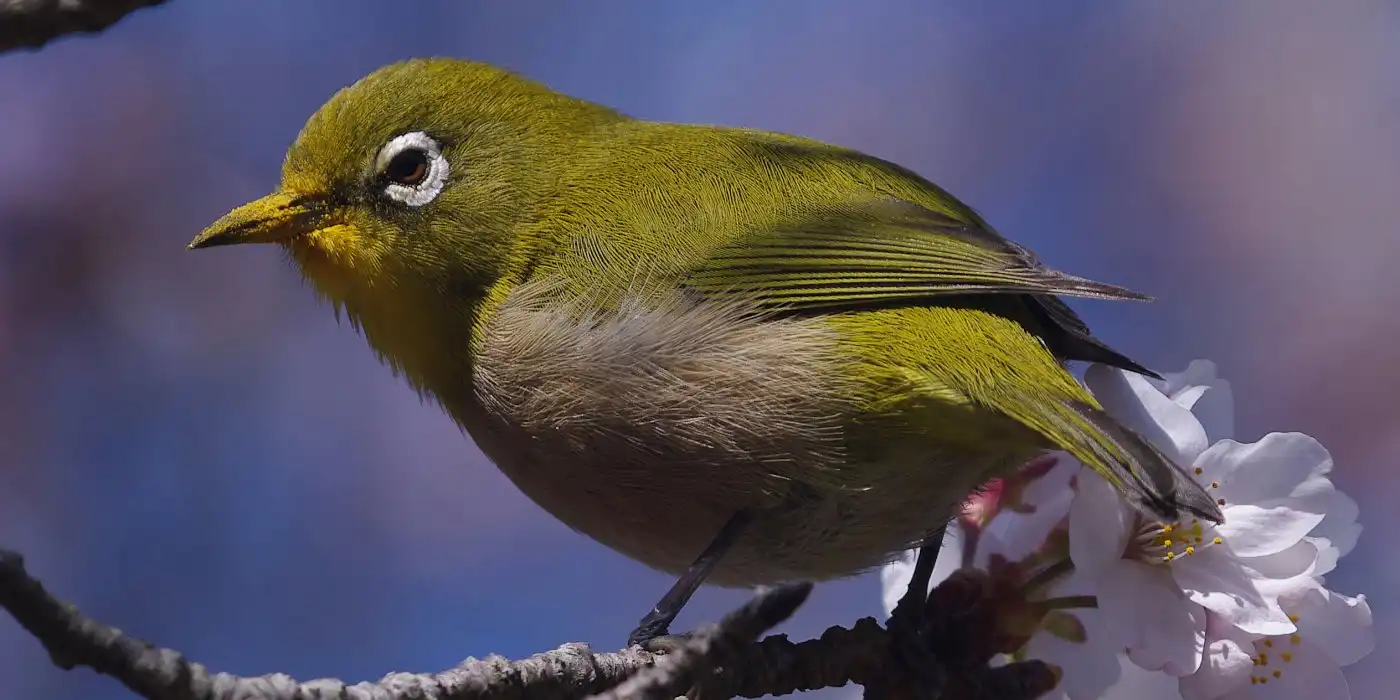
0, 0, 165, 52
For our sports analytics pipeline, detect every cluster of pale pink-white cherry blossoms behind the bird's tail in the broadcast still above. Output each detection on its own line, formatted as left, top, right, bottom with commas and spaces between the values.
882, 360, 1375, 700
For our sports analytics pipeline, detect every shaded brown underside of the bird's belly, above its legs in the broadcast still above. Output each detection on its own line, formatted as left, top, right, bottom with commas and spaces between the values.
472, 406, 979, 587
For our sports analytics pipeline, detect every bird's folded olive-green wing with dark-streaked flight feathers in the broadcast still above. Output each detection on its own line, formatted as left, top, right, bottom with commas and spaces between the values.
685, 196, 1151, 309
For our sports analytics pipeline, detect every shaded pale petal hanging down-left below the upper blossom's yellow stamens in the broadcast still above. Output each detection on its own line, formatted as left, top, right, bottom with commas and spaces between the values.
1095, 561, 1205, 676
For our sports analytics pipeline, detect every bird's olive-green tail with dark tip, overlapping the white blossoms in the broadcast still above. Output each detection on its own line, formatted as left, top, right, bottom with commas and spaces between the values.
1016, 398, 1224, 522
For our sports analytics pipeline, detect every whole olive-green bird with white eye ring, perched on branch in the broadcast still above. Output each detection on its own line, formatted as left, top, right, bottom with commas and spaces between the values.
190, 59, 1221, 643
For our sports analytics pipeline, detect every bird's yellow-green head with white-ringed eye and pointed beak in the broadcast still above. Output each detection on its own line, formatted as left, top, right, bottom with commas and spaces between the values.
189, 59, 619, 312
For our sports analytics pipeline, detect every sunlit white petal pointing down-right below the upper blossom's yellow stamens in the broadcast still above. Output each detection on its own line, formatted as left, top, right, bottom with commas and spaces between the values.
1169, 542, 1296, 634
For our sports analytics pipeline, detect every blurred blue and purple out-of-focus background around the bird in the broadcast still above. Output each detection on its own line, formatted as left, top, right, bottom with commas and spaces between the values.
0, 0, 1400, 700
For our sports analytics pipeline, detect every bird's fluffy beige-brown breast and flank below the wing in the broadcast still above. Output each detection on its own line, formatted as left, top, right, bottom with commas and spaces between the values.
455, 283, 868, 579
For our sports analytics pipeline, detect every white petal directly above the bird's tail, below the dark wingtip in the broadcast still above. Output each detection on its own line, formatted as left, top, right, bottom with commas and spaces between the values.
1085, 364, 1207, 465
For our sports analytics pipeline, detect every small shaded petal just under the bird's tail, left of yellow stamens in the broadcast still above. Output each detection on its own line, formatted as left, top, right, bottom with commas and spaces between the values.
1070, 469, 1137, 578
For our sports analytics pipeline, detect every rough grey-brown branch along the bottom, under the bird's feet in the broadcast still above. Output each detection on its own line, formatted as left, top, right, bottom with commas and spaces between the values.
0, 550, 1053, 700
